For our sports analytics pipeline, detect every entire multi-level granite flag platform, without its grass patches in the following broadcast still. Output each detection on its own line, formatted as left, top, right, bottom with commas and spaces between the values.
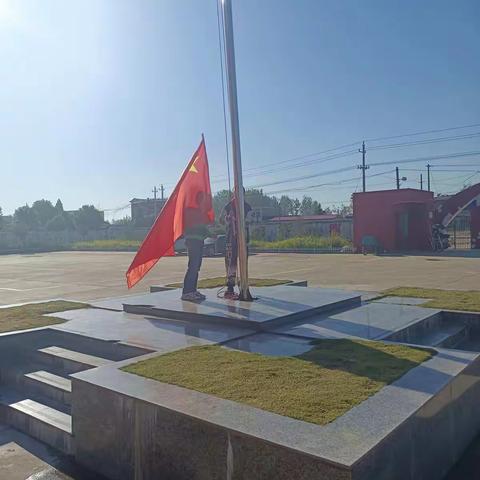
0, 286, 480, 480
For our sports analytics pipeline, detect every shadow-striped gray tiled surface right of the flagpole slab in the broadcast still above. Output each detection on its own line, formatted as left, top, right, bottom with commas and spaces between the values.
275, 302, 440, 339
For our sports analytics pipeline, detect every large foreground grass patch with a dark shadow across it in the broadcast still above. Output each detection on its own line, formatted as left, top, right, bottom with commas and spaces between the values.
123, 339, 434, 425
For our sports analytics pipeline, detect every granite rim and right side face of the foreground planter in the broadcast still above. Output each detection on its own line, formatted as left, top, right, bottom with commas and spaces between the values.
73, 349, 480, 479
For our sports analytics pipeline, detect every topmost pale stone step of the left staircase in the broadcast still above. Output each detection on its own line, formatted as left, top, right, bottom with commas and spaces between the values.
37, 346, 112, 374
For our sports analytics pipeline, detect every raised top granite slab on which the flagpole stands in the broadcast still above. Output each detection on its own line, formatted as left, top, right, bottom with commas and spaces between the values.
119, 285, 361, 330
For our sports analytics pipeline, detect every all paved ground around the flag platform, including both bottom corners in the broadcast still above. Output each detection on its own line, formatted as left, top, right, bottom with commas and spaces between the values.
0, 252, 480, 480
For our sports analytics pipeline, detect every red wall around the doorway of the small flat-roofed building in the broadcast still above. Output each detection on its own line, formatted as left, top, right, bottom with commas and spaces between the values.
353, 188, 433, 251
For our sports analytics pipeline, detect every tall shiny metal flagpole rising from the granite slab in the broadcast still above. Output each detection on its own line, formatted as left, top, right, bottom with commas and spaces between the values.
222, 0, 252, 300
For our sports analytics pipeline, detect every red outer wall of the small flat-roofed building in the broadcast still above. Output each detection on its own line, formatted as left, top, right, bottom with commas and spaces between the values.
353, 188, 433, 251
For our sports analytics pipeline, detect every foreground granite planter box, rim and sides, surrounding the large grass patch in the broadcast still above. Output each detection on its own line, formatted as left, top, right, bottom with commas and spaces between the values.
72, 342, 480, 480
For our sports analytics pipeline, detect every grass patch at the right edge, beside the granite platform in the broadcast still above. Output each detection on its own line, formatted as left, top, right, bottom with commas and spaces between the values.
382, 287, 480, 312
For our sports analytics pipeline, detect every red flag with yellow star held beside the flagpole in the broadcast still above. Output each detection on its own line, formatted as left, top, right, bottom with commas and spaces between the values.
126, 137, 215, 288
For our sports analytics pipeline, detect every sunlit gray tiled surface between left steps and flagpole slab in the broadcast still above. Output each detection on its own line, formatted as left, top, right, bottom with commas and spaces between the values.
47, 309, 253, 352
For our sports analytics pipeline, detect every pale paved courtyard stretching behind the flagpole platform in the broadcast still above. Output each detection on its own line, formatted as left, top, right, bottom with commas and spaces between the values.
0, 252, 480, 305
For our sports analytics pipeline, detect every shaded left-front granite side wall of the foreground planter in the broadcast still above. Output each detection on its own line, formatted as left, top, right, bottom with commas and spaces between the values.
72, 374, 351, 480
